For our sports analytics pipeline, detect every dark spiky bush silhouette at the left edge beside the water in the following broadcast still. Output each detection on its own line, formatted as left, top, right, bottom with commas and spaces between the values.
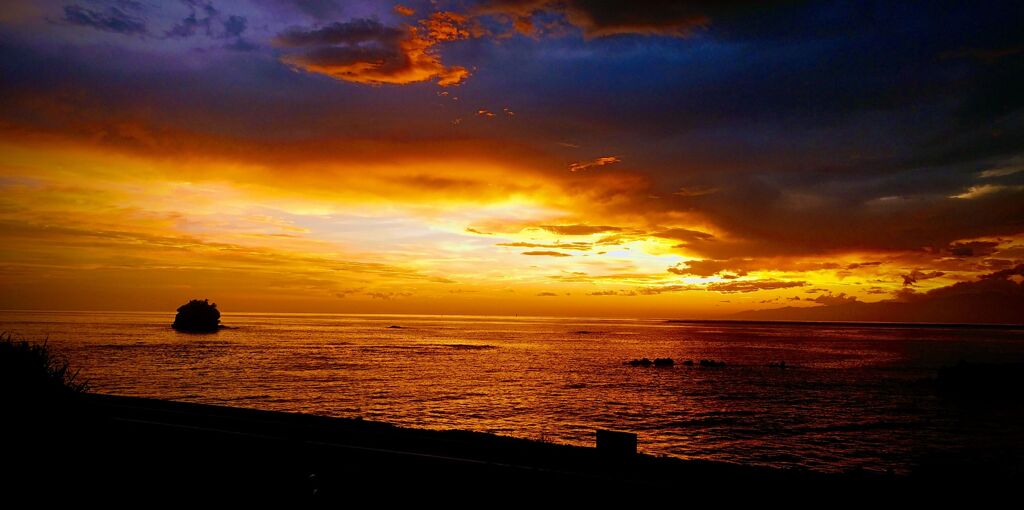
0, 333, 87, 405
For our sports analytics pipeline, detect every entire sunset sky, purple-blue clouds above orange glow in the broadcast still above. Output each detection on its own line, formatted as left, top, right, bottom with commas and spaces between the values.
0, 0, 1024, 322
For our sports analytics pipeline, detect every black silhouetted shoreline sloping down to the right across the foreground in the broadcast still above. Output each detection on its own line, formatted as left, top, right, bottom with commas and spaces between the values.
8, 393, 999, 500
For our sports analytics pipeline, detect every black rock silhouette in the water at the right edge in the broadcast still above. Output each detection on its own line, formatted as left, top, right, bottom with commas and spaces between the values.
936, 359, 1024, 399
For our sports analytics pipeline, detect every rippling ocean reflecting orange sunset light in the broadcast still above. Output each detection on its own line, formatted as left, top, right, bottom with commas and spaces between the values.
0, 311, 1024, 473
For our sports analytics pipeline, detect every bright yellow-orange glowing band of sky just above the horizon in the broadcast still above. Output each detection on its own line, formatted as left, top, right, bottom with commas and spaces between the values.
0, 136, 1007, 317
